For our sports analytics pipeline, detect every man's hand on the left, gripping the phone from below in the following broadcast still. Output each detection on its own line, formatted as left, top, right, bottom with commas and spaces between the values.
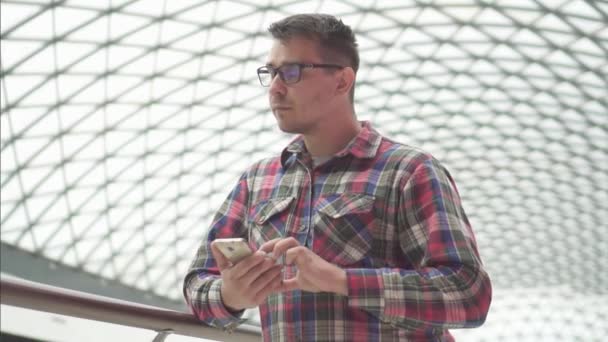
211, 241, 283, 312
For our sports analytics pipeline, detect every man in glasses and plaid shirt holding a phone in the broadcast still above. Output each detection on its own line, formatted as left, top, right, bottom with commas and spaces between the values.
184, 14, 491, 341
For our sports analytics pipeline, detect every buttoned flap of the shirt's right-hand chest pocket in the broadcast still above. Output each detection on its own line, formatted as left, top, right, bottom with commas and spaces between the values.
318, 194, 375, 218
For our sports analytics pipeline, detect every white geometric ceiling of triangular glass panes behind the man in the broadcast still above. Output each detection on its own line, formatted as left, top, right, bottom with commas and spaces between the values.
0, 0, 608, 341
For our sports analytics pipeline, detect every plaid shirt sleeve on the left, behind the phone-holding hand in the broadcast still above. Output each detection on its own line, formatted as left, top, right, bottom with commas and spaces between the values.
183, 175, 248, 331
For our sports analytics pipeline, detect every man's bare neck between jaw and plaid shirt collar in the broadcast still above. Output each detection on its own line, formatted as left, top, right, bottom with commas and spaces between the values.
303, 112, 361, 157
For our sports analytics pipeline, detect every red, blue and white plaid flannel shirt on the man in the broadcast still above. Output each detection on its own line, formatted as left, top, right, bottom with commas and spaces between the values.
184, 122, 492, 341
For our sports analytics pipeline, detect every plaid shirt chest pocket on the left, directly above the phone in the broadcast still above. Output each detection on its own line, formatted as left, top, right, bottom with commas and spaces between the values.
249, 197, 294, 248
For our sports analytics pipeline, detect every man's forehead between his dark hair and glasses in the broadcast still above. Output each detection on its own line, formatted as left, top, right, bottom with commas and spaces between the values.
267, 37, 321, 66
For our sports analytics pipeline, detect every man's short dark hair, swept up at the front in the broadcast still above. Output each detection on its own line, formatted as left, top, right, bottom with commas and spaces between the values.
268, 13, 359, 102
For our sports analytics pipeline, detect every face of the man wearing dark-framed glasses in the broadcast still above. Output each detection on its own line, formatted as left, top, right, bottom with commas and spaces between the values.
266, 37, 336, 134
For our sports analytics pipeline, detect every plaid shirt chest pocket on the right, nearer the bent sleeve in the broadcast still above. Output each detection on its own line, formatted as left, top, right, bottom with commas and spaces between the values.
313, 194, 376, 266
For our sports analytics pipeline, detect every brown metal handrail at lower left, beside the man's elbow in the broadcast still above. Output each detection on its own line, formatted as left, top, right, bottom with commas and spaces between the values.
0, 274, 261, 342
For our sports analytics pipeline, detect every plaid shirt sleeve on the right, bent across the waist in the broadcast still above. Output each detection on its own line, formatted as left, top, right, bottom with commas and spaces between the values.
346, 158, 492, 329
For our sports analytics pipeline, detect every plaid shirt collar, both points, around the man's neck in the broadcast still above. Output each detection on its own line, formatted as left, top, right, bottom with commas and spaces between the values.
281, 121, 382, 167
